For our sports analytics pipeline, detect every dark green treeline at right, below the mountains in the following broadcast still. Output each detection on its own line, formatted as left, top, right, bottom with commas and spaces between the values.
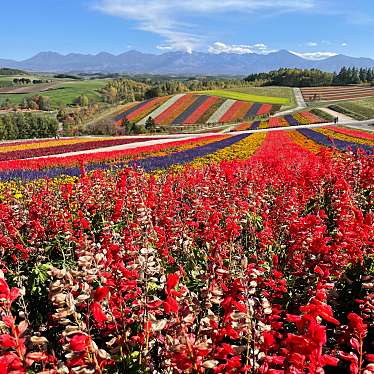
244, 67, 374, 87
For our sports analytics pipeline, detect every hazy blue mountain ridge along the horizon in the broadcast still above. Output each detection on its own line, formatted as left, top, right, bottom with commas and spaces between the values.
0, 50, 374, 75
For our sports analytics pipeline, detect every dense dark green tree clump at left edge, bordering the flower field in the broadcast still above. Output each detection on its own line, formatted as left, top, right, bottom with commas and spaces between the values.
0, 113, 58, 140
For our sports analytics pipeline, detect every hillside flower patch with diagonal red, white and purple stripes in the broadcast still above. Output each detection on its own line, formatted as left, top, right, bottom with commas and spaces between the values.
116, 94, 280, 126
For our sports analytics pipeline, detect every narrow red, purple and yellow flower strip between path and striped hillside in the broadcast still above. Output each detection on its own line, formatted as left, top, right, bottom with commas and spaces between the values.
231, 112, 327, 131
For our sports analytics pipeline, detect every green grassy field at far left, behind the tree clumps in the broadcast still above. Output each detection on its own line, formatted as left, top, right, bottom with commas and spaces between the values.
0, 79, 107, 109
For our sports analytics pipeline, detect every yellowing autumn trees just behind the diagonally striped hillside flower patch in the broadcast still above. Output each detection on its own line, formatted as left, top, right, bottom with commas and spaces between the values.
101, 78, 250, 103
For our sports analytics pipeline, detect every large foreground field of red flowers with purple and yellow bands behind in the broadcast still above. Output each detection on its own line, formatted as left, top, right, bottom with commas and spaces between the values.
0, 126, 374, 374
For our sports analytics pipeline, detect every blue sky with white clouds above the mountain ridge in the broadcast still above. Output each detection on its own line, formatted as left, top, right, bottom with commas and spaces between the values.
0, 0, 374, 60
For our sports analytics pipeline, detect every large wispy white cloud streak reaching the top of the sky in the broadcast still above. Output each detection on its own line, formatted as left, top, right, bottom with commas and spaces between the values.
95, 0, 317, 52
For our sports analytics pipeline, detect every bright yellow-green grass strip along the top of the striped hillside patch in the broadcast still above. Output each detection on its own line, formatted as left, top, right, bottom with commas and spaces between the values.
198, 87, 291, 105
